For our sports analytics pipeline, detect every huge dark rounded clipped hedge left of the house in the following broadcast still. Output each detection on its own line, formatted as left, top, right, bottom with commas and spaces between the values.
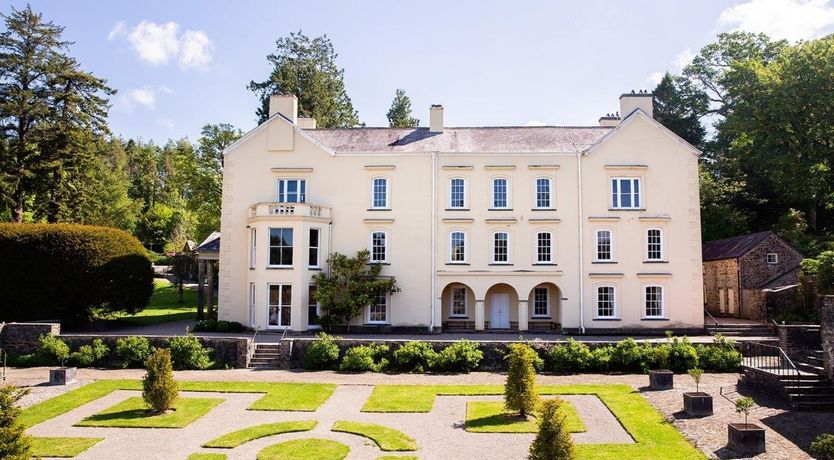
0, 224, 153, 323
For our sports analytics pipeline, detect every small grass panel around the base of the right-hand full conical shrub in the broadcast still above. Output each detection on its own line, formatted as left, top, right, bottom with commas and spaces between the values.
466, 401, 588, 433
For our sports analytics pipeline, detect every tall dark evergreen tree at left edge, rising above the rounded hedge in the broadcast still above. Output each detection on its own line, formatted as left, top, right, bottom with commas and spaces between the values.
0, 6, 114, 222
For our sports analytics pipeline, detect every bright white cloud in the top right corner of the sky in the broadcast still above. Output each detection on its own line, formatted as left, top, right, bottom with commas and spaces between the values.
718, 0, 834, 41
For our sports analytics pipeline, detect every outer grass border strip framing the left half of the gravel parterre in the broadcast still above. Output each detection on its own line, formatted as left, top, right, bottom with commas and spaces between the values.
20, 380, 336, 428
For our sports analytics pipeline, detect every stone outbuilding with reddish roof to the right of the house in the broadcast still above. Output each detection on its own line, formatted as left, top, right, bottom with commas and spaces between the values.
702, 231, 803, 321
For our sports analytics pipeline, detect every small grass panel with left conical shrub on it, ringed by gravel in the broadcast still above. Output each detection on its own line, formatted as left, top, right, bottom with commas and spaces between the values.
75, 397, 224, 428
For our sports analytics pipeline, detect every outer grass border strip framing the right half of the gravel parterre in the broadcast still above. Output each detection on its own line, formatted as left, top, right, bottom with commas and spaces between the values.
362, 385, 706, 460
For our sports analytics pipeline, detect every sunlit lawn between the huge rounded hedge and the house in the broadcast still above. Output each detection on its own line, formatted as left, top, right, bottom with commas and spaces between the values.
109, 278, 197, 326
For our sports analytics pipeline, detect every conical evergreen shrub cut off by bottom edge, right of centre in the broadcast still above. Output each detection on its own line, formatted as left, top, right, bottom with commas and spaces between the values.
527, 398, 576, 460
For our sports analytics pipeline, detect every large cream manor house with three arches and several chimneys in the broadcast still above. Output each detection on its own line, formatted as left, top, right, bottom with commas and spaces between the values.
219, 92, 704, 333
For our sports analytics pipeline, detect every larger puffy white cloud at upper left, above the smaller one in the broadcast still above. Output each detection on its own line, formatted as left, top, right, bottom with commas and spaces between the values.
112, 21, 214, 69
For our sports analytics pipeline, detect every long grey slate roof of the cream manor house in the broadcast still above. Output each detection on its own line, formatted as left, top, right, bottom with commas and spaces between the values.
304, 126, 613, 153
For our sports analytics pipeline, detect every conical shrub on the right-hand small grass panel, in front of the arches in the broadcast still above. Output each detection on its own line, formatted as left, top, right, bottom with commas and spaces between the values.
504, 343, 539, 417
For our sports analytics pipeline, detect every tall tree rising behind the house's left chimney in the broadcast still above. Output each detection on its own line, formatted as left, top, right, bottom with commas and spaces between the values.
248, 30, 360, 128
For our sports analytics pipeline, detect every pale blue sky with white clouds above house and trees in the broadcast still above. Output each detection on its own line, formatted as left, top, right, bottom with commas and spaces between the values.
9, 0, 834, 143
